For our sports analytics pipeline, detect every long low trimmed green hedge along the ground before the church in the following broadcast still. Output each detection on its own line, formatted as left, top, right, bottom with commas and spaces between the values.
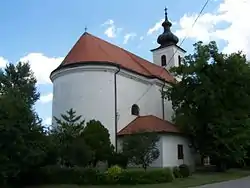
19, 166, 174, 185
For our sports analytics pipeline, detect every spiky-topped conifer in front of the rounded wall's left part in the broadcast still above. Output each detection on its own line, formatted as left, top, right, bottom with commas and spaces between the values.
52, 108, 91, 166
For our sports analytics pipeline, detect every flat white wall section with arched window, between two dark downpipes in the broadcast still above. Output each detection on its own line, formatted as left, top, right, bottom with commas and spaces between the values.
117, 74, 162, 131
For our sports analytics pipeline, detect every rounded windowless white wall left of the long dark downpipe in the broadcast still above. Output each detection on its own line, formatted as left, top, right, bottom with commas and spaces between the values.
52, 67, 115, 144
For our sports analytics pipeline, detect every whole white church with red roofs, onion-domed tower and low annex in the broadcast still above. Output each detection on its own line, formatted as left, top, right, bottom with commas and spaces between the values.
50, 10, 194, 167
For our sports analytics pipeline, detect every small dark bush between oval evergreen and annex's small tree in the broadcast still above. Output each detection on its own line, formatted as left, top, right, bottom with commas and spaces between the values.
108, 153, 128, 168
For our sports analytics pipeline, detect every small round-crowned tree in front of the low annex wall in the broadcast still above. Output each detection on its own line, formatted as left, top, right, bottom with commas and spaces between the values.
122, 131, 160, 170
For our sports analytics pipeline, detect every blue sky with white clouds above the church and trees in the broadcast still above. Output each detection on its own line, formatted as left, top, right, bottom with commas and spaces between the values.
0, 0, 250, 123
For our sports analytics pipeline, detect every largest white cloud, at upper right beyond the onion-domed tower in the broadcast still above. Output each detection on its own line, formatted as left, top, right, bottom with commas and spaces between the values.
176, 0, 250, 58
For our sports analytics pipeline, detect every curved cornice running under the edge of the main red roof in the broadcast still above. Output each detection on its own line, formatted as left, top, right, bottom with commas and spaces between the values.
50, 62, 168, 86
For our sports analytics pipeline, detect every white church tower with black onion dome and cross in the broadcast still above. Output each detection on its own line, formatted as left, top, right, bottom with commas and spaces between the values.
151, 8, 186, 70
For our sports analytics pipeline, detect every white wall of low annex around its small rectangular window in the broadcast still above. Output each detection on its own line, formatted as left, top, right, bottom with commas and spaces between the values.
162, 134, 195, 167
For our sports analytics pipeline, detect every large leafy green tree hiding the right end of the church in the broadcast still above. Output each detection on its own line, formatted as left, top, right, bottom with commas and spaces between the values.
165, 42, 250, 170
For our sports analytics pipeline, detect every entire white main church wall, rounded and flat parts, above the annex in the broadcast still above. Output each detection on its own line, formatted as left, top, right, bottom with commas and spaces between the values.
52, 66, 176, 148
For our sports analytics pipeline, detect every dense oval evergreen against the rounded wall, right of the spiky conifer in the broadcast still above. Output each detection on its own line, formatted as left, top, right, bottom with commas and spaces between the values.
83, 120, 113, 166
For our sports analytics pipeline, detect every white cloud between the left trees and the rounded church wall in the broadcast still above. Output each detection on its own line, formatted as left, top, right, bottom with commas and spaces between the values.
20, 53, 64, 84
